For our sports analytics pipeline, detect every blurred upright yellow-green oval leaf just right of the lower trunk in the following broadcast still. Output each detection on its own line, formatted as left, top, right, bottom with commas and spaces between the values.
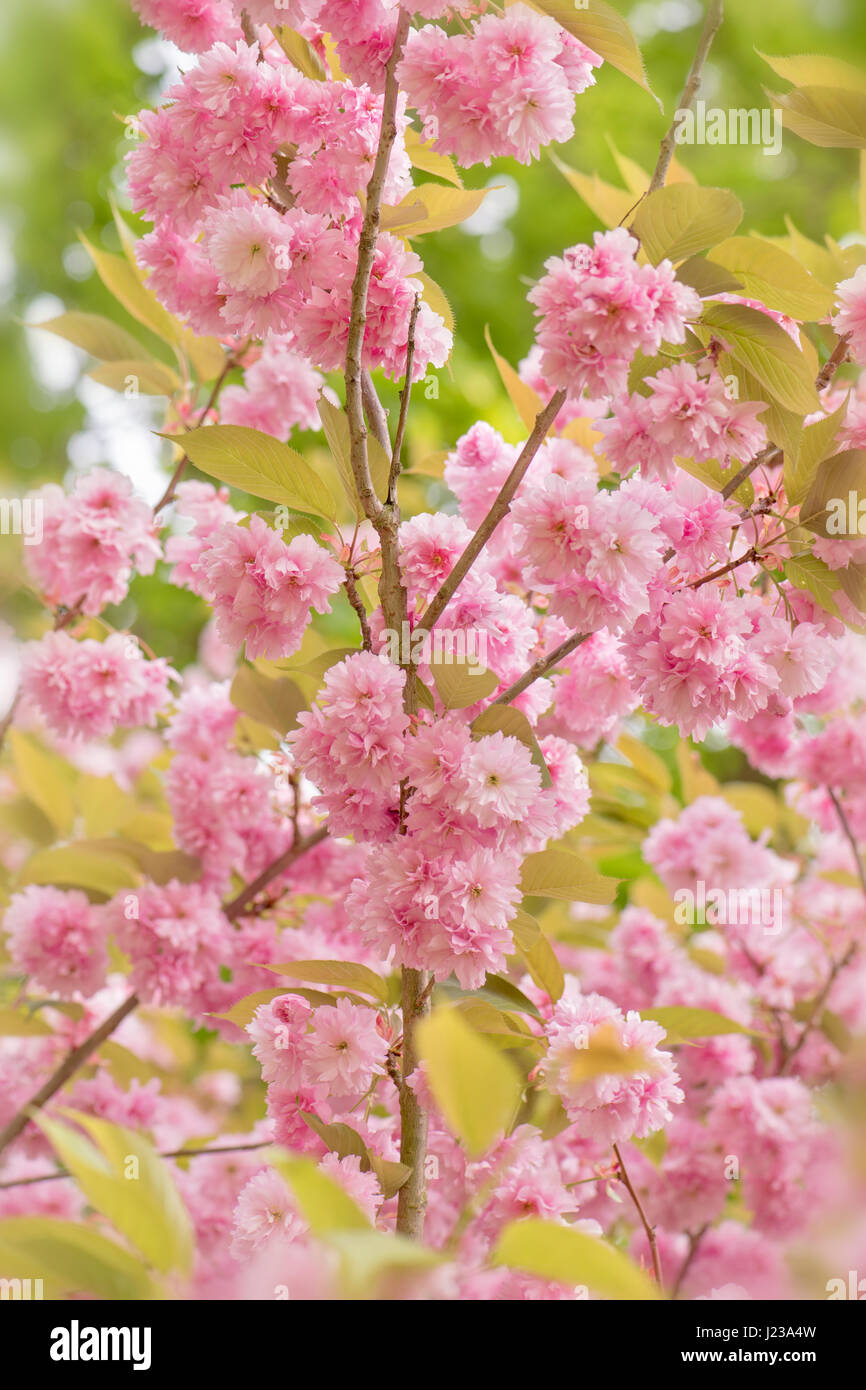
418, 1009, 521, 1158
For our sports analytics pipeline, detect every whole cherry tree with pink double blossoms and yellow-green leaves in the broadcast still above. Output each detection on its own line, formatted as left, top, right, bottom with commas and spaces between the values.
0, 0, 866, 1300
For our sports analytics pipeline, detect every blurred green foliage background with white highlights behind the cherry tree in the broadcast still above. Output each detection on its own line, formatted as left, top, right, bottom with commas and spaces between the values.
0, 0, 866, 660
